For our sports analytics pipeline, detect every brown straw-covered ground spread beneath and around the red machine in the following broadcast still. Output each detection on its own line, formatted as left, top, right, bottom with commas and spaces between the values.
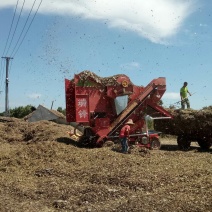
0, 118, 212, 212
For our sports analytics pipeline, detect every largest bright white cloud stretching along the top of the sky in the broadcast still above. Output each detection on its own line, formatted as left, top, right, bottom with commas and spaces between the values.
0, 0, 197, 43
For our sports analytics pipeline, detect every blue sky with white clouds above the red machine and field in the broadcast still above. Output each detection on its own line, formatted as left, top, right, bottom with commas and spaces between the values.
0, 0, 212, 112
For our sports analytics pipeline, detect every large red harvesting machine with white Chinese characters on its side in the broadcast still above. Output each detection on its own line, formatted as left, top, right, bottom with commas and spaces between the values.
65, 71, 172, 149
